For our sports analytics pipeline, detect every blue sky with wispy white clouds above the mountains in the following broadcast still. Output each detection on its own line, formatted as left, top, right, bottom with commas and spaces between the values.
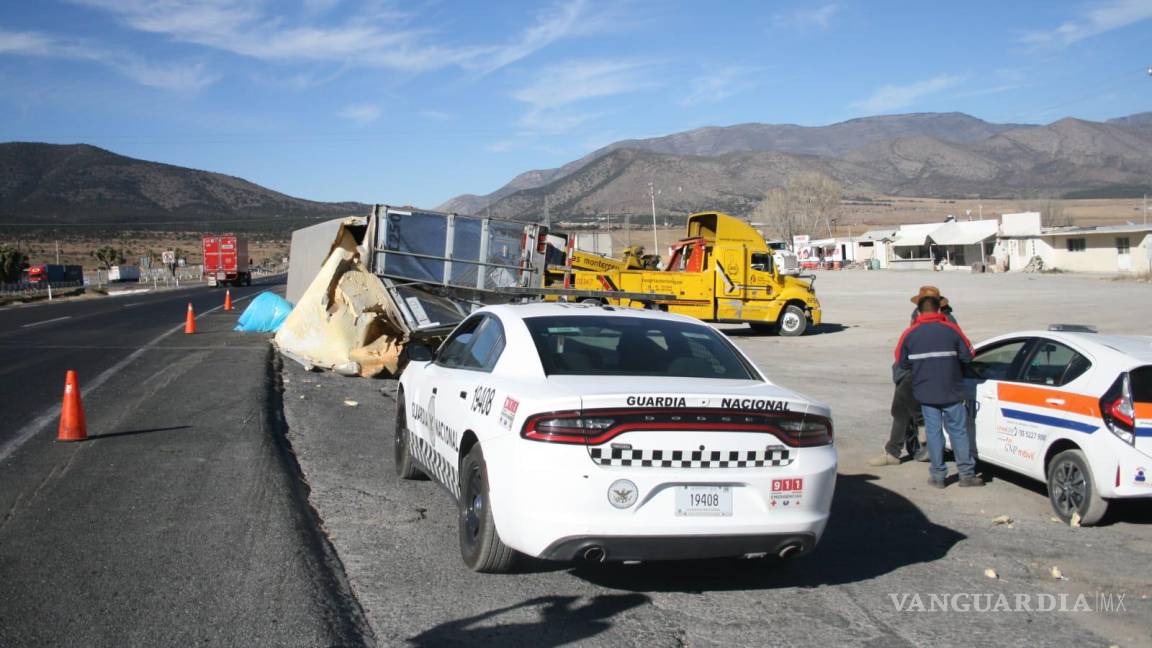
0, 0, 1152, 206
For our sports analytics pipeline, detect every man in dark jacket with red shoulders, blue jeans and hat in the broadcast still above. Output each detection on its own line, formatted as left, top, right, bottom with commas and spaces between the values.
896, 296, 984, 488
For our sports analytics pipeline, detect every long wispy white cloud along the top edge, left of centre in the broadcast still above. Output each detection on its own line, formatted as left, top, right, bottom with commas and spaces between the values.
65, 0, 600, 71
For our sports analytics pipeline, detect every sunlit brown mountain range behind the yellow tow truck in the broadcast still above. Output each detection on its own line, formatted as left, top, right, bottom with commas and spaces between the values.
439, 113, 1152, 219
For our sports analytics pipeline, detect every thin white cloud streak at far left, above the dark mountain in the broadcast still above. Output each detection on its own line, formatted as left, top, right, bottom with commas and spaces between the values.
0, 30, 220, 92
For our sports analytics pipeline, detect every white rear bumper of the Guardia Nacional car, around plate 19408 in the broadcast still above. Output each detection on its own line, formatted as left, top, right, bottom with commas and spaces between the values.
485, 435, 836, 560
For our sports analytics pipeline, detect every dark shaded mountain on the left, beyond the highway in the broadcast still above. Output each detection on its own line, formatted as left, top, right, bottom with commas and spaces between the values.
0, 142, 369, 226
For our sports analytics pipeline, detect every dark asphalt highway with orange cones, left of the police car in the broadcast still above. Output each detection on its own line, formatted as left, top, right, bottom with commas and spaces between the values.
0, 281, 372, 646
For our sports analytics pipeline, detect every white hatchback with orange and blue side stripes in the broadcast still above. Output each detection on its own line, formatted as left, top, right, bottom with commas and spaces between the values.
971, 325, 1152, 525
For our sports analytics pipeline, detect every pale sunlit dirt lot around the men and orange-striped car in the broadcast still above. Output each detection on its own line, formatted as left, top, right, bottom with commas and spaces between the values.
720, 266, 1152, 645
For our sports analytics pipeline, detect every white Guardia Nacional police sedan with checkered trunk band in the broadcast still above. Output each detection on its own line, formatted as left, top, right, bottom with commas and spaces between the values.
395, 303, 836, 572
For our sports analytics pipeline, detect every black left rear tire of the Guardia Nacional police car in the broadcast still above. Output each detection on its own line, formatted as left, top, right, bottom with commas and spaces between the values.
457, 444, 516, 574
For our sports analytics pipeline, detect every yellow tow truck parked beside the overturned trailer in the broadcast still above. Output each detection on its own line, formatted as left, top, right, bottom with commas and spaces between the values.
547, 212, 820, 337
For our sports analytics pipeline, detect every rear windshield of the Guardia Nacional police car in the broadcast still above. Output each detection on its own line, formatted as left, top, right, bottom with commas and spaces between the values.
524, 316, 759, 380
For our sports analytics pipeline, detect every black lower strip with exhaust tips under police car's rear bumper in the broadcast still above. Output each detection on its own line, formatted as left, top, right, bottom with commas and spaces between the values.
540, 533, 817, 562
